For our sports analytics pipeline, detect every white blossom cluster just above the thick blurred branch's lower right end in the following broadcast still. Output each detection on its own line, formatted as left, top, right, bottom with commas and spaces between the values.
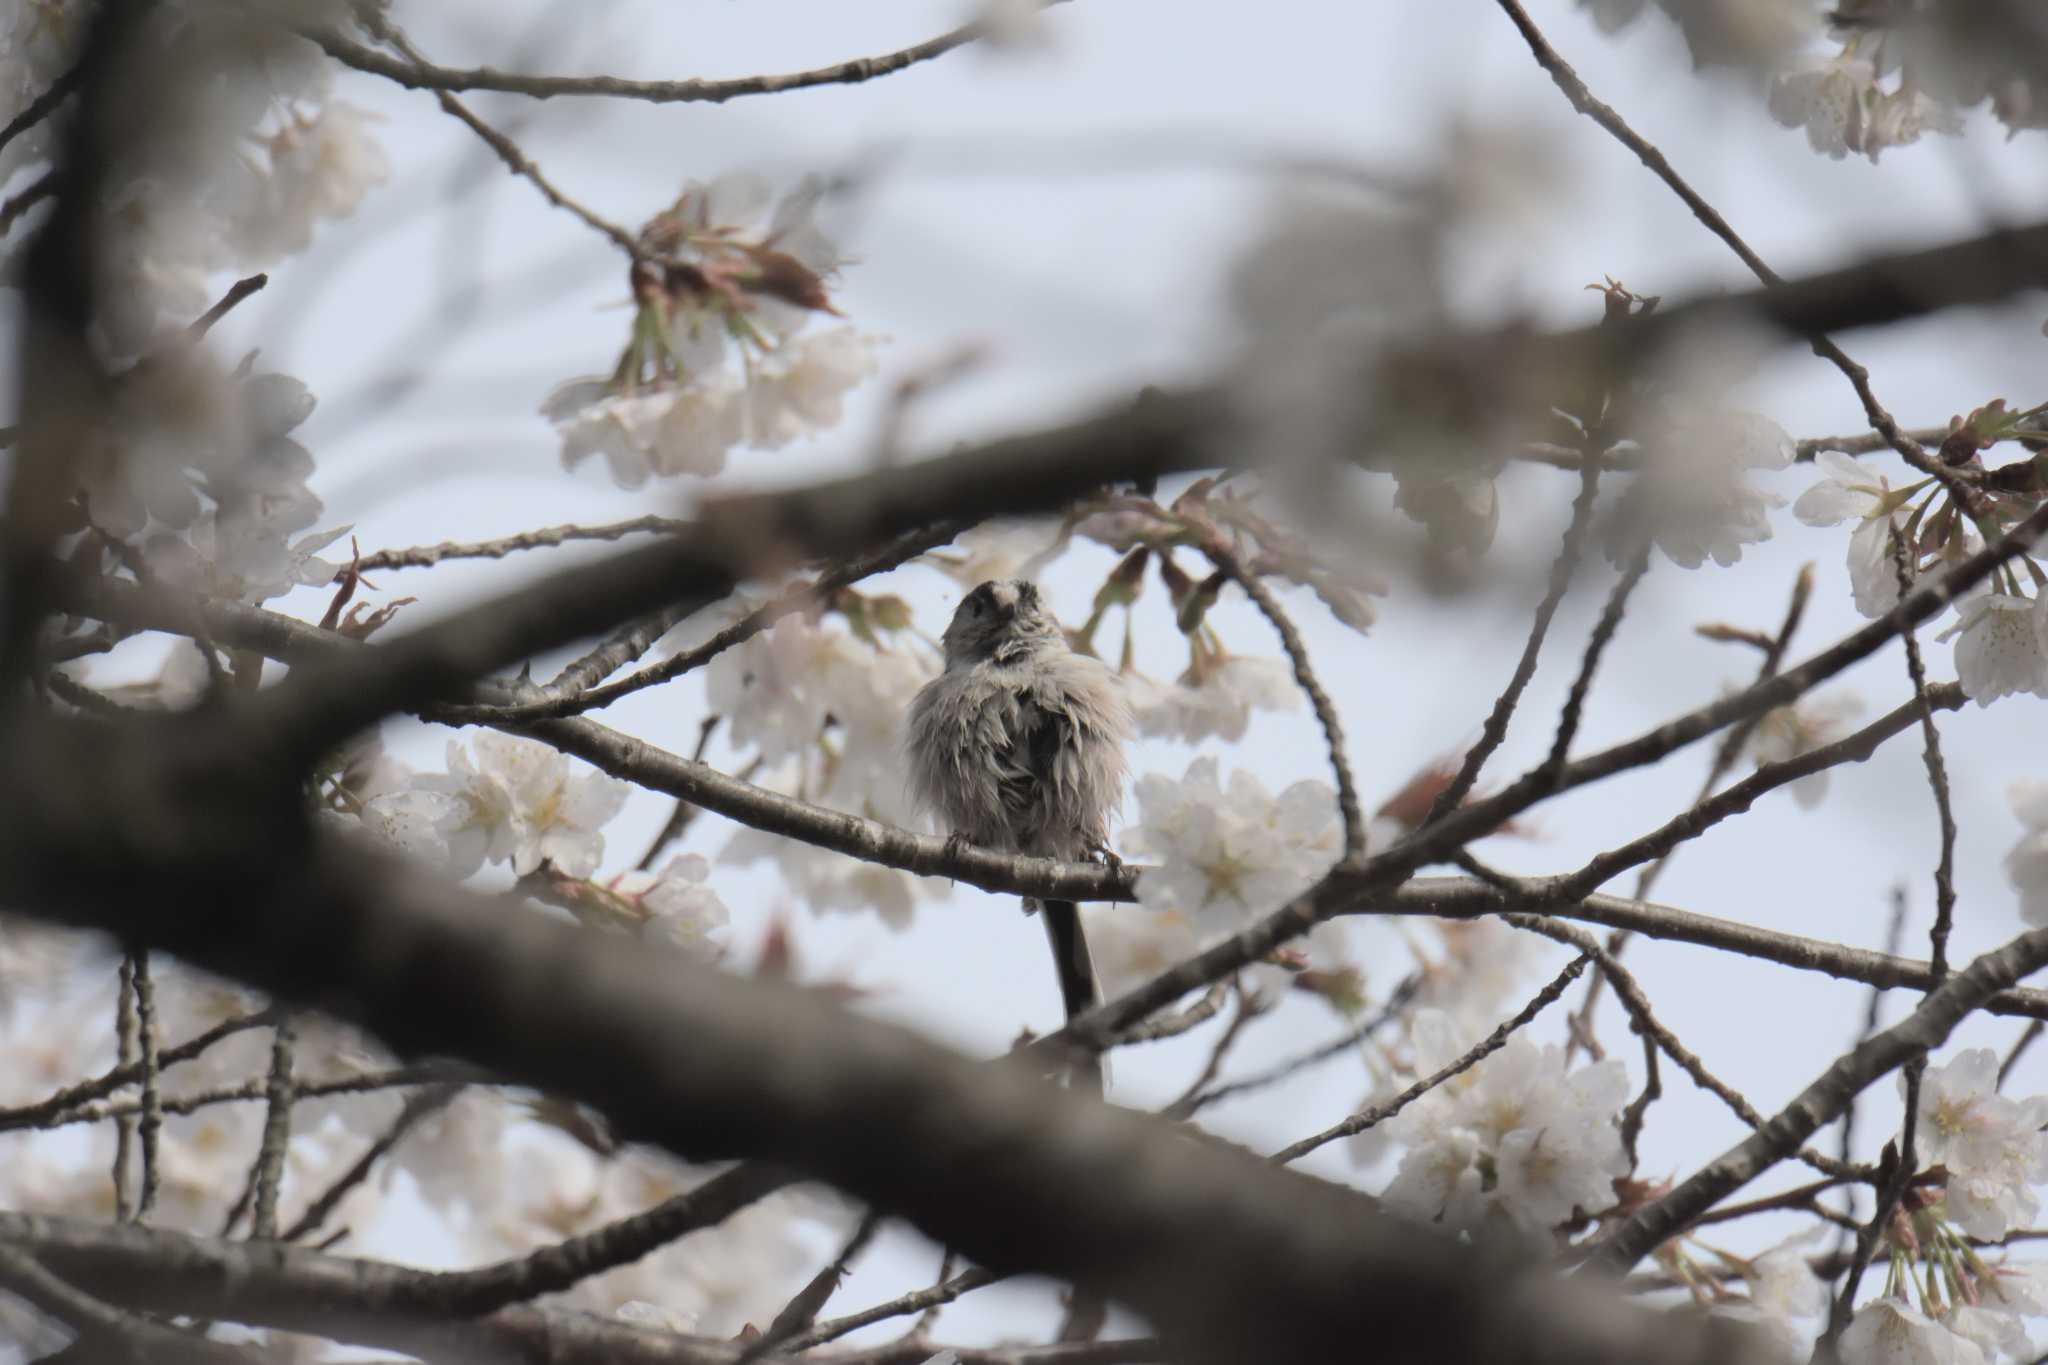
1382, 1009, 1628, 1240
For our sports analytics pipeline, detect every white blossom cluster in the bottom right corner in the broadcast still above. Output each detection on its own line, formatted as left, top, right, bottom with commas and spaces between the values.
1841, 1048, 2048, 1365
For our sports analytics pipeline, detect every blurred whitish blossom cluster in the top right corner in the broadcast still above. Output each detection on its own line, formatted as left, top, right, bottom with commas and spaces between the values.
1579, 0, 2048, 162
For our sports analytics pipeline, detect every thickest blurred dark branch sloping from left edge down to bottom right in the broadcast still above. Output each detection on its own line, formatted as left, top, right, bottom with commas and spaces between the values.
0, 826, 1777, 1365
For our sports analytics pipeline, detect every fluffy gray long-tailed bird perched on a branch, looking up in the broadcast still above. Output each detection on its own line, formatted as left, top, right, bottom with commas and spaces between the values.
909, 579, 1133, 1085
